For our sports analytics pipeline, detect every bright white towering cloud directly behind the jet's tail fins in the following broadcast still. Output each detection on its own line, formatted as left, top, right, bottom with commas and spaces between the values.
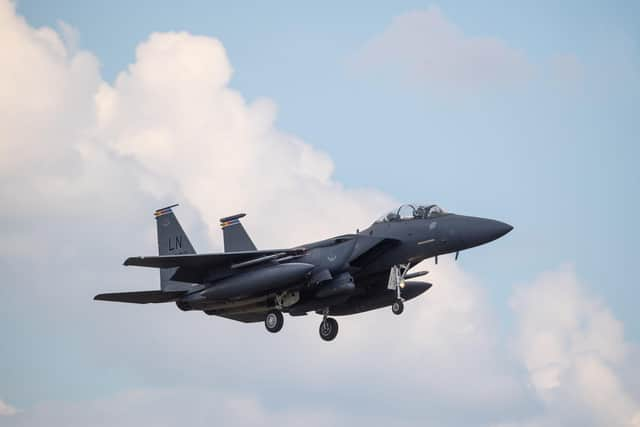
96, 33, 392, 247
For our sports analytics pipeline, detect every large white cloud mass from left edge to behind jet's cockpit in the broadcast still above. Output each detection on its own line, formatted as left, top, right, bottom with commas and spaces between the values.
0, 2, 393, 254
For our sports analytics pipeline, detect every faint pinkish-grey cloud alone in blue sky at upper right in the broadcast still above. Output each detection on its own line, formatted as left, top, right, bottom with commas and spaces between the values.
355, 6, 535, 91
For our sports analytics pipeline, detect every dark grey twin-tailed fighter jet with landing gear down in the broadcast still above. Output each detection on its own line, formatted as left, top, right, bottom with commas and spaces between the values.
94, 204, 513, 341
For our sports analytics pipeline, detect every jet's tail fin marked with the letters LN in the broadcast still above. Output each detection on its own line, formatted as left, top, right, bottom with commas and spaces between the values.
154, 205, 196, 292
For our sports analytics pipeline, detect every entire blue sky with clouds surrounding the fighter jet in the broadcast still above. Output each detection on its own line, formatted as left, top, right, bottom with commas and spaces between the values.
0, 0, 640, 427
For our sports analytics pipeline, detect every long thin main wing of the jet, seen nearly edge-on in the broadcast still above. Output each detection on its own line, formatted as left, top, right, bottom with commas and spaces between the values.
124, 249, 303, 268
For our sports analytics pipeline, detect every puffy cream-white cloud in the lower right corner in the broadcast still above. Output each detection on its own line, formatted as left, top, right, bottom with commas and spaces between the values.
512, 268, 640, 426
